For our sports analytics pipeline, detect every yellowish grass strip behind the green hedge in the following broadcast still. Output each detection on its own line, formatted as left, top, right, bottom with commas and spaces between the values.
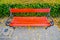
0, 0, 60, 4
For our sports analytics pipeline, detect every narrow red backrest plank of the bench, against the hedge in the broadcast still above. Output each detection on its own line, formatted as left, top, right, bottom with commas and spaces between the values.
10, 8, 50, 13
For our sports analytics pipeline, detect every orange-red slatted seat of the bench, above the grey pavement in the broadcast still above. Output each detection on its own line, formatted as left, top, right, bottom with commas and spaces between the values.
9, 17, 50, 27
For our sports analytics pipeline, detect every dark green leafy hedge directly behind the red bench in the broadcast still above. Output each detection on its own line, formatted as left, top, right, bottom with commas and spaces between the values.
0, 3, 60, 17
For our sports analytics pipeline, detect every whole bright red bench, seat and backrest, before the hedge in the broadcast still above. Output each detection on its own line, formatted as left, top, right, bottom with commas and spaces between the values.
6, 8, 53, 27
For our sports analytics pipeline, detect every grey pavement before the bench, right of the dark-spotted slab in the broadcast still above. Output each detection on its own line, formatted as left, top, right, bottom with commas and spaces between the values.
0, 26, 60, 40
